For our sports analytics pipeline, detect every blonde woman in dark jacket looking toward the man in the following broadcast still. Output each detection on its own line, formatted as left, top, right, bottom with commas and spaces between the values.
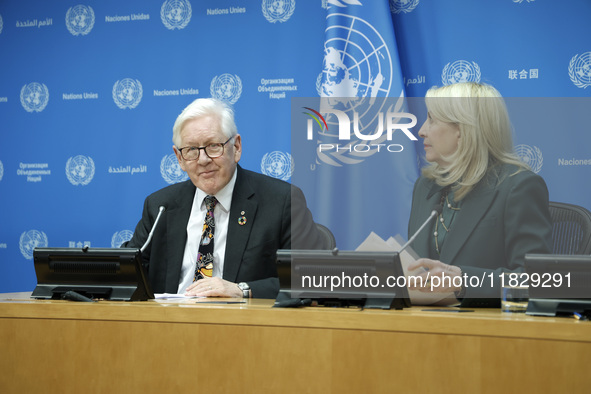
408, 82, 552, 307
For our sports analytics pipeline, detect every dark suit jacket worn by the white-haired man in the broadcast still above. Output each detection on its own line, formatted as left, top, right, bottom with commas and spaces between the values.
124, 166, 322, 298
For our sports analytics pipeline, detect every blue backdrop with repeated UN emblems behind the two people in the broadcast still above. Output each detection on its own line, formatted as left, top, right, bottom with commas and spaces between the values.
0, 0, 591, 292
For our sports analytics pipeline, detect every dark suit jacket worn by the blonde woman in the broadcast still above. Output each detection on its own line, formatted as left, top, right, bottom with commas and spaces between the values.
408, 165, 552, 307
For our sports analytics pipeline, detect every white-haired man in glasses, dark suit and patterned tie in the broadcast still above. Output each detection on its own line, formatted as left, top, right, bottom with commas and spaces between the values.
125, 99, 322, 298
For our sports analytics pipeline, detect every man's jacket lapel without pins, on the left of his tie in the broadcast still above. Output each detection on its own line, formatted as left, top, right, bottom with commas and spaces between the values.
164, 181, 196, 292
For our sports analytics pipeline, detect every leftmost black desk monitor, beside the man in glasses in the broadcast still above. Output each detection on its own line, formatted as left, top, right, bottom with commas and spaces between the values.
31, 247, 154, 301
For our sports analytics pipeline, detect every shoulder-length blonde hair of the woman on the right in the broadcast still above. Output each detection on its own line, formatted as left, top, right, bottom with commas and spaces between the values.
422, 82, 528, 201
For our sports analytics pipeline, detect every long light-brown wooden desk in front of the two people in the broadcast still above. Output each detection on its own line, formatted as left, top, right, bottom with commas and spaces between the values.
0, 293, 591, 394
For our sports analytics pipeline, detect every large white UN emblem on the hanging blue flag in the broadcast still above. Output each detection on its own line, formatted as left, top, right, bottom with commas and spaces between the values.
316, 14, 396, 166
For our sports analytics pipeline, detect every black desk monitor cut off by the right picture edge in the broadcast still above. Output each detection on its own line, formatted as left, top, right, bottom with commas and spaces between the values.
525, 254, 591, 316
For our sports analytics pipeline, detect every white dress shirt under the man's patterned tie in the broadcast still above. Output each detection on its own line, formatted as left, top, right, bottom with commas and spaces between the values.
178, 171, 238, 294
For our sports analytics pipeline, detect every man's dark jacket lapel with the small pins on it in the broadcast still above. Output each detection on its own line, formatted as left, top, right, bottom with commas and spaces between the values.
223, 166, 258, 282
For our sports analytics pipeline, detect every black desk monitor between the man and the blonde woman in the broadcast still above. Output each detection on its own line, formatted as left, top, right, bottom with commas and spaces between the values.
277, 249, 410, 309
